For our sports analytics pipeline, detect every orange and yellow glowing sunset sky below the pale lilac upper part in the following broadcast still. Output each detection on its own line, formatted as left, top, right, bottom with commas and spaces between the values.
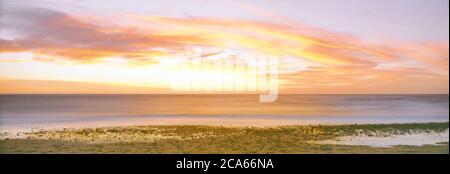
0, 1, 449, 93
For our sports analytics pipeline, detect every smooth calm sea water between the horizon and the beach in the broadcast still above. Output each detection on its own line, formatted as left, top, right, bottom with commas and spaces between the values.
0, 95, 449, 126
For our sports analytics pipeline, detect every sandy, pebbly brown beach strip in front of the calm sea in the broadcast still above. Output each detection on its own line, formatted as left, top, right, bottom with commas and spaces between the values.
0, 122, 449, 154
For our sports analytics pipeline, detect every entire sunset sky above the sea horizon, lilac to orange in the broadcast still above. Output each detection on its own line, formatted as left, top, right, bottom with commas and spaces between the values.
0, 0, 449, 94
